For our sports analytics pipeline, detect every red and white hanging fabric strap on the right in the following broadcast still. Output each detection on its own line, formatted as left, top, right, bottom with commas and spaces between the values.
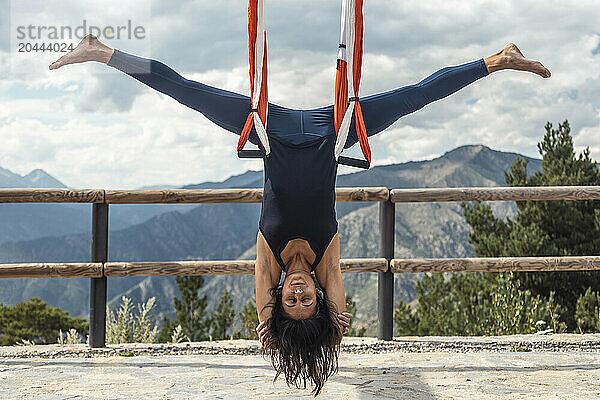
333, 0, 371, 163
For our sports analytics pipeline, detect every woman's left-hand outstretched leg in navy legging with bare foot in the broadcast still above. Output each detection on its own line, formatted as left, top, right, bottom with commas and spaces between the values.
50, 35, 250, 135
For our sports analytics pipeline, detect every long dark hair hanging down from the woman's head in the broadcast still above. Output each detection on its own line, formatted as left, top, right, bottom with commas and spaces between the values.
263, 280, 342, 397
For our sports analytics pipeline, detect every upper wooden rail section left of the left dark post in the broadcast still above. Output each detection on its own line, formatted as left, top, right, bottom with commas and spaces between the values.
0, 188, 104, 203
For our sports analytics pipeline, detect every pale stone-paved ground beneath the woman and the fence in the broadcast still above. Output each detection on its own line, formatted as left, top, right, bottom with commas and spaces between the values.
0, 335, 600, 400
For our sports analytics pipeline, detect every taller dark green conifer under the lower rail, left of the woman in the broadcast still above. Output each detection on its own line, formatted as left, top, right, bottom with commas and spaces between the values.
173, 276, 211, 342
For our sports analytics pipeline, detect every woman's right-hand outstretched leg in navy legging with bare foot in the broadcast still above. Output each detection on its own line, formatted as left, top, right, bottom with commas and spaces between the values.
352, 43, 550, 141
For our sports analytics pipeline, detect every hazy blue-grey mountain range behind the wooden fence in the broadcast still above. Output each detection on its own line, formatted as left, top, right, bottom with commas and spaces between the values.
0, 145, 541, 333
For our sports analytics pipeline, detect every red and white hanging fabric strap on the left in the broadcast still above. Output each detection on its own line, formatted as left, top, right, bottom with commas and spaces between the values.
237, 0, 271, 155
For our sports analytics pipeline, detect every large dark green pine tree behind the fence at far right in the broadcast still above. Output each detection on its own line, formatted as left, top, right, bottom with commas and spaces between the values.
462, 121, 600, 331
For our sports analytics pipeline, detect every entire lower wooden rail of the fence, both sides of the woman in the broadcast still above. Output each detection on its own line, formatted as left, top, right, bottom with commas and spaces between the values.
8, 256, 600, 279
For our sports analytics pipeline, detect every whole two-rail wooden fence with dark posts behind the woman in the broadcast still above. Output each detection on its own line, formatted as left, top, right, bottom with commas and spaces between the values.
0, 186, 600, 347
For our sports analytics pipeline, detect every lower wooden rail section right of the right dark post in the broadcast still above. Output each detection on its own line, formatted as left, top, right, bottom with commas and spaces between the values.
390, 256, 600, 273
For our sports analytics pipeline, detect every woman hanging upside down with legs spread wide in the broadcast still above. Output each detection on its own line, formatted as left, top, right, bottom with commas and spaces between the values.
50, 35, 550, 394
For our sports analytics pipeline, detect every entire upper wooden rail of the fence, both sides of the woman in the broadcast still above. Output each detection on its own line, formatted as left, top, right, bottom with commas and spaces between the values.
7, 186, 600, 204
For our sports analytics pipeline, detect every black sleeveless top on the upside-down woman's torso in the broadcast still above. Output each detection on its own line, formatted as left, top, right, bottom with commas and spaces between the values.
258, 135, 338, 271
